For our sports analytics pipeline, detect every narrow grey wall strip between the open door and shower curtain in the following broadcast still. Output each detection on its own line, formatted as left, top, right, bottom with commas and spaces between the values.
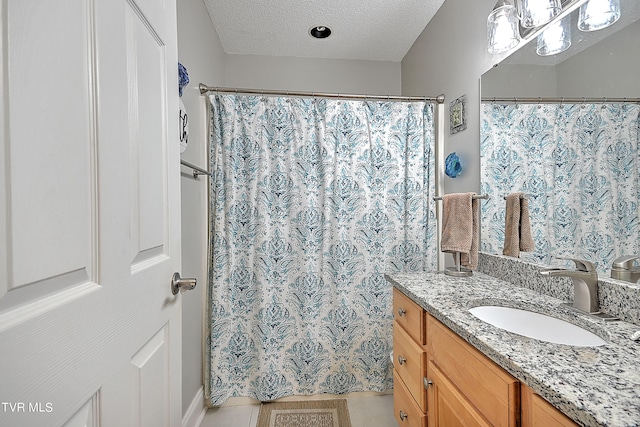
178, 0, 224, 415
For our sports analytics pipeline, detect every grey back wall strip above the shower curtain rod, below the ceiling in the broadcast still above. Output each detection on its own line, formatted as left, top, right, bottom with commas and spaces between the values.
225, 55, 401, 95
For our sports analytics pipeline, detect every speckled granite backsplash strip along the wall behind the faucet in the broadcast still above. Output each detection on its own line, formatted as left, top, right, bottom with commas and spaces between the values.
478, 252, 640, 326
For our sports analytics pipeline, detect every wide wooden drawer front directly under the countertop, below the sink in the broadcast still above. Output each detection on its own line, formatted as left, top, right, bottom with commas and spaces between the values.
427, 316, 520, 426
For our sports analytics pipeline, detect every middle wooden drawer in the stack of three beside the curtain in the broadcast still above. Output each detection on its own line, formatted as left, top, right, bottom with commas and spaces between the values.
393, 322, 427, 412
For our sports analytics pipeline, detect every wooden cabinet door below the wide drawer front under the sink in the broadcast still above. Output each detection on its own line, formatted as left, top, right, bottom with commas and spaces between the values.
427, 360, 491, 427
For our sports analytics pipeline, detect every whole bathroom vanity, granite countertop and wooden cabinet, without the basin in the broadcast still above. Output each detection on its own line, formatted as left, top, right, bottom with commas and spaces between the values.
387, 273, 640, 427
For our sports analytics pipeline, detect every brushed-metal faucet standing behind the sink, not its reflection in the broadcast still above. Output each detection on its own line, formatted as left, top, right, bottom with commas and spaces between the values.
540, 258, 600, 313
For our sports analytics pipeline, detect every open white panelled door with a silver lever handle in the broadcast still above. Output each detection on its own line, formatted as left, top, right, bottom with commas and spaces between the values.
0, 0, 181, 427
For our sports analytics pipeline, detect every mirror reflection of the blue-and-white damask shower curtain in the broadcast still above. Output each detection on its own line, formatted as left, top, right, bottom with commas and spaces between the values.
480, 103, 640, 273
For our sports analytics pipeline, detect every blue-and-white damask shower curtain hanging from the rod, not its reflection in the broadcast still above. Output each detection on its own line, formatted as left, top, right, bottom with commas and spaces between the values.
205, 94, 437, 405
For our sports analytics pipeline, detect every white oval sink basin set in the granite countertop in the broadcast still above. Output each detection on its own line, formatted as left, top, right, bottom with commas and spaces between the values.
469, 305, 606, 347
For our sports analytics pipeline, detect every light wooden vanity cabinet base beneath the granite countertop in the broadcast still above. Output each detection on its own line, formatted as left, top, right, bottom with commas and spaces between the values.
393, 288, 577, 427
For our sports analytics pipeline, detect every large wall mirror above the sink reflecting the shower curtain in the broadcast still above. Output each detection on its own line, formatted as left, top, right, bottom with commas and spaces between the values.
480, 0, 640, 276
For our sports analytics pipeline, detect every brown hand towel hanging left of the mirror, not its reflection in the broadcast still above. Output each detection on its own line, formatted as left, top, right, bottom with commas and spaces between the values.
440, 193, 480, 270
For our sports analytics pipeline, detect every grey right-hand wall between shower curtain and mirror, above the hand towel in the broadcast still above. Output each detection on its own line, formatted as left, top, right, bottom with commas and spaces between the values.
402, 0, 506, 193
